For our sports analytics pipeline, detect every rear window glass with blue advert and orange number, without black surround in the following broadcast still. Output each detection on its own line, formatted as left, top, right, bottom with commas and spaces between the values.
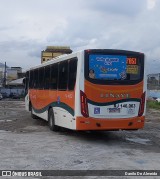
88, 54, 141, 81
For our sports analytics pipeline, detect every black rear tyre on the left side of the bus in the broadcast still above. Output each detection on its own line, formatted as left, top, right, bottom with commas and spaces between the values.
48, 109, 59, 132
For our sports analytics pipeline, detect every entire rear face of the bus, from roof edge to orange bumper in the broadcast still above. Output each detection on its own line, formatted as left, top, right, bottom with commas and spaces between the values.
76, 50, 146, 130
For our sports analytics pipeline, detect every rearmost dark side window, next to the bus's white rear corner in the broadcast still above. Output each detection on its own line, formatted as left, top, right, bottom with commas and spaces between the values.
68, 59, 77, 90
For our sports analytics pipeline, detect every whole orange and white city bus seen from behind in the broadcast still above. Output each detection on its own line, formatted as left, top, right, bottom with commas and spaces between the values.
25, 49, 146, 131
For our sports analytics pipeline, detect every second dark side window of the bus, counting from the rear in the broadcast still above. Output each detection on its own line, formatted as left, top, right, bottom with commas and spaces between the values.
58, 61, 68, 90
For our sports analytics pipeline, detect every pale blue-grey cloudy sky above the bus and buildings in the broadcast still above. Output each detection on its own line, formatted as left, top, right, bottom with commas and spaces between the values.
0, 0, 160, 73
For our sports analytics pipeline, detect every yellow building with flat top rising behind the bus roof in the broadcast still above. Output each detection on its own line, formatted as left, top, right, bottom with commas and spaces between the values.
41, 46, 72, 63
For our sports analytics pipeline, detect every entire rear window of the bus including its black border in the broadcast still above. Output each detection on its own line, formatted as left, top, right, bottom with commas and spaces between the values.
86, 49, 144, 84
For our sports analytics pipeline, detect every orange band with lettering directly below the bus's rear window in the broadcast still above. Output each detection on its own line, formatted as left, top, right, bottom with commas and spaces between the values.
84, 81, 143, 103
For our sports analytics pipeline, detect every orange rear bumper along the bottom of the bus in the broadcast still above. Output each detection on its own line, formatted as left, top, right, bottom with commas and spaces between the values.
76, 116, 145, 130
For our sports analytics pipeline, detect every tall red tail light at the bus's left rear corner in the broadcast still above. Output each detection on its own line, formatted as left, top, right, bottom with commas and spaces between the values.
80, 91, 89, 117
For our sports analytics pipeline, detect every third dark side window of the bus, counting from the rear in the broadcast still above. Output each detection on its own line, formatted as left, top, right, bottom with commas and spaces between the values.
50, 64, 58, 90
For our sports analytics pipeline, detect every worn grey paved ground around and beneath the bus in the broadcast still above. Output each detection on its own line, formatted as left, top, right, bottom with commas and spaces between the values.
0, 101, 160, 178
